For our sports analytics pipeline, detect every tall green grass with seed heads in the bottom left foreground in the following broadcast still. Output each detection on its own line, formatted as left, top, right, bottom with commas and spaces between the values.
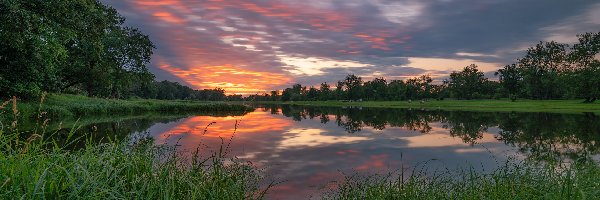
0, 96, 270, 199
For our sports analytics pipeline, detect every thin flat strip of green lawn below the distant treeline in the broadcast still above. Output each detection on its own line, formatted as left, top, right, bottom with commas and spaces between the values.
266, 100, 600, 113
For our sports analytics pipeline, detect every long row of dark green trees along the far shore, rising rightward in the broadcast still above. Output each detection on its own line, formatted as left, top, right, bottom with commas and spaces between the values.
248, 32, 600, 102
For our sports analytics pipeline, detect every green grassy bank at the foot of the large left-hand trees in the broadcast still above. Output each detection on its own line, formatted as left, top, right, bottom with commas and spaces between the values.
5, 94, 251, 117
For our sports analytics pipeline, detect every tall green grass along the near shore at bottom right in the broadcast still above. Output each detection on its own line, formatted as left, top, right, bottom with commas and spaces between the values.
325, 162, 600, 199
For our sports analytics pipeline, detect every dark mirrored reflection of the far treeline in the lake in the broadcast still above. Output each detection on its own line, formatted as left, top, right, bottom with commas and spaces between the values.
261, 105, 600, 161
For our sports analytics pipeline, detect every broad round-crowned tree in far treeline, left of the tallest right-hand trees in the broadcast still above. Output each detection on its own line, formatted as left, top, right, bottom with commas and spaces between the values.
449, 64, 487, 99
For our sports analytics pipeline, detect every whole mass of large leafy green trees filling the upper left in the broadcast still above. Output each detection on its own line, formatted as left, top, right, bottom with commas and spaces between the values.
0, 0, 154, 98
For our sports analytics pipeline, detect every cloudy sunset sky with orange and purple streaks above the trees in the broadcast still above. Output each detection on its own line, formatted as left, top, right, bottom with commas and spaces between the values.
101, 0, 600, 94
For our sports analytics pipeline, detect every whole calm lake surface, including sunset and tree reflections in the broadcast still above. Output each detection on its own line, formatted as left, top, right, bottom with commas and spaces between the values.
49, 105, 600, 199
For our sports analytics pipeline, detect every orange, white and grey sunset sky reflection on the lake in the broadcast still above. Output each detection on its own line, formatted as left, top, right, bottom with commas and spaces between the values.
138, 108, 528, 199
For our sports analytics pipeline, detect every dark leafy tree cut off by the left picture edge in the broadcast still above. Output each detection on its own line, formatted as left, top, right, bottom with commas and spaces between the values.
0, 0, 67, 97
